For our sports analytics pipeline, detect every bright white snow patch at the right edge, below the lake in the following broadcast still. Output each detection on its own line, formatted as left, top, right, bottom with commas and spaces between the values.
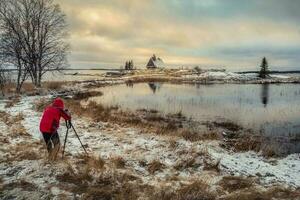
212, 152, 300, 187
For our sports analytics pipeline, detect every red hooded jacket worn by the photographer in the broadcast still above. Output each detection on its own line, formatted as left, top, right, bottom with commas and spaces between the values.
40, 98, 71, 133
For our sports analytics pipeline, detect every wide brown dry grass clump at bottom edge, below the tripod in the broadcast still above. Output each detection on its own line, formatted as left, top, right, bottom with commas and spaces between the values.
56, 166, 151, 200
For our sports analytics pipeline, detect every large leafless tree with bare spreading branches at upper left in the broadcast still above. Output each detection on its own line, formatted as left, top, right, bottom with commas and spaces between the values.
0, 0, 68, 87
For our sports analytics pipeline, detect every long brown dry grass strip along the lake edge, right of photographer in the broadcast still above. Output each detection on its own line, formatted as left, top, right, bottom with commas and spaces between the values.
64, 99, 220, 141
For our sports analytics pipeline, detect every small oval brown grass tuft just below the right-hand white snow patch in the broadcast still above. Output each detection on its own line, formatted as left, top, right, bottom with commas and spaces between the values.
219, 176, 254, 192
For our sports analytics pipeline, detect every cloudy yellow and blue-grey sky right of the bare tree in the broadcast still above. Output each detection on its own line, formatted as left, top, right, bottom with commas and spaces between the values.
56, 0, 300, 70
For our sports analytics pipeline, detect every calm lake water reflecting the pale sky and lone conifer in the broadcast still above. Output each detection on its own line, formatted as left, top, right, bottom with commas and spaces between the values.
93, 83, 300, 152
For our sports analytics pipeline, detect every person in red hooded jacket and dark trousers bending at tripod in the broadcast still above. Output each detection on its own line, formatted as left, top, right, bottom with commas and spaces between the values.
40, 98, 71, 155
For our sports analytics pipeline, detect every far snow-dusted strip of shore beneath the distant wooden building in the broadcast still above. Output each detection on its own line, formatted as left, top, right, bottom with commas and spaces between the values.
68, 69, 300, 87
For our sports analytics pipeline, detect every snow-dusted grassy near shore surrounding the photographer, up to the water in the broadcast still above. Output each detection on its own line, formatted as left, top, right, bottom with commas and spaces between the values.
0, 71, 300, 200
